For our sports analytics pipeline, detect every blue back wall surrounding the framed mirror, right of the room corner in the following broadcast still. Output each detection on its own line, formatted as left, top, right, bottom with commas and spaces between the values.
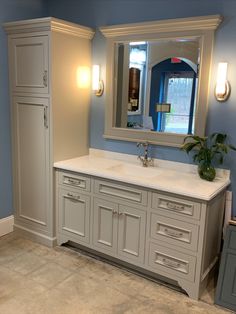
48, 0, 236, 215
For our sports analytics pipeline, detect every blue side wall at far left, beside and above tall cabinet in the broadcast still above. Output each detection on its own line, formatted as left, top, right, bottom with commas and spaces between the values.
0, 0, 44, 218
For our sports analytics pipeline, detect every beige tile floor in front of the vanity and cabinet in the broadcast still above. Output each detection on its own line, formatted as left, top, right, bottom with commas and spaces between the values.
0, 233, 231, 314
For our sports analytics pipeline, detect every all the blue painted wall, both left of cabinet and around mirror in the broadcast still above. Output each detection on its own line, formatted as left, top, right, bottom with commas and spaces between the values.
0, 0, 236, 218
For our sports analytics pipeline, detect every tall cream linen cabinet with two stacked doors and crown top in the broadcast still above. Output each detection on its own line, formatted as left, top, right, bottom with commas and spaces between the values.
4, 18, 94, 246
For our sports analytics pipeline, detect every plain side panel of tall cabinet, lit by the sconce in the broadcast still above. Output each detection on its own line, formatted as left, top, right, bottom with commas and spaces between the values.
51, 31, 91, 162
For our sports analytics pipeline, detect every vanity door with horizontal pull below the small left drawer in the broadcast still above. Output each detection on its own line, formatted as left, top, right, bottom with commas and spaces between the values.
58, 188, 90, 243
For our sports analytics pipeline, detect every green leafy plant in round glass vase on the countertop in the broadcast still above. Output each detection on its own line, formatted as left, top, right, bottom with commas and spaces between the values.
181, 133, 236, 181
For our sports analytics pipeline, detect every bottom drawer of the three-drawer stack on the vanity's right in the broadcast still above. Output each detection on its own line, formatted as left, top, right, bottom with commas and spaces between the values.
148, 243, 196, 281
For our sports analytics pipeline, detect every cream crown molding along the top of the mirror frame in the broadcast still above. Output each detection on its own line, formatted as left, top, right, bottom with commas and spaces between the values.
99, 15, 222, 38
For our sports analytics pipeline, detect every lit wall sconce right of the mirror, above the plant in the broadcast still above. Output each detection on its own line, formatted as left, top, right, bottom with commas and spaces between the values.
215, 62, 230, 102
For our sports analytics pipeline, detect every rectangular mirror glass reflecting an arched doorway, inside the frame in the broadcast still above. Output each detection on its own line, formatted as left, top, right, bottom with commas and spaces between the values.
115, 38, 199, 134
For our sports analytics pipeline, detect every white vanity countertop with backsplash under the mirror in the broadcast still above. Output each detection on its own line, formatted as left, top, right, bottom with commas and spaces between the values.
54, 149, 230, 201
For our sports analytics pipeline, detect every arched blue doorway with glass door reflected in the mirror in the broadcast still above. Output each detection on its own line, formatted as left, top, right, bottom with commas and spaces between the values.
150, 58, 197, 134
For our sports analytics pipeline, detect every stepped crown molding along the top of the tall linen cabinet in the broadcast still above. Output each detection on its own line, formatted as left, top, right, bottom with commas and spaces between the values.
3, 17, 94, 39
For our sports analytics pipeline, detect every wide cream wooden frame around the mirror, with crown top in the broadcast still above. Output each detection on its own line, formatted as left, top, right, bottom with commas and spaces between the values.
100, 15, 222, 147
